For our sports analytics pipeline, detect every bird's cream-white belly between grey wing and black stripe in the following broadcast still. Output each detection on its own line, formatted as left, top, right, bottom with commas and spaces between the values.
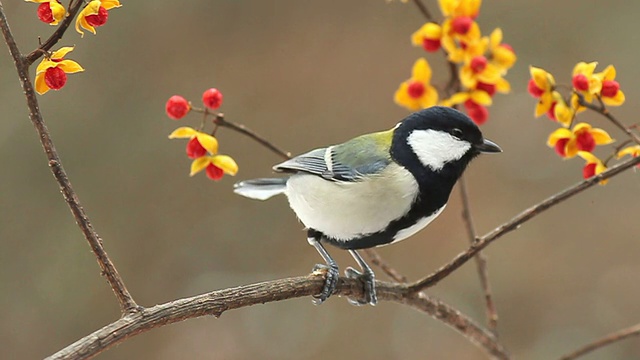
285, 163, 426, 240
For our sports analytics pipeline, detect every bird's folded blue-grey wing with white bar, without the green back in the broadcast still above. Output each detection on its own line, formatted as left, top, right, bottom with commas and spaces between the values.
273, 145, 391, 181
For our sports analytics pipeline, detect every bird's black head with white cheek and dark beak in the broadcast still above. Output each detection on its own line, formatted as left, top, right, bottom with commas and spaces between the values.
391, 106, 502, 173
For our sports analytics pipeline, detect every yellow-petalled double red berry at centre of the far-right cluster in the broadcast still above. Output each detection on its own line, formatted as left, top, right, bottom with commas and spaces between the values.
547, 123, 614, 159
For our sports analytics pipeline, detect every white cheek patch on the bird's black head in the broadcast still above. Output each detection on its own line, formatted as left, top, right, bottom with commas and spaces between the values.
407, 130, 471, 171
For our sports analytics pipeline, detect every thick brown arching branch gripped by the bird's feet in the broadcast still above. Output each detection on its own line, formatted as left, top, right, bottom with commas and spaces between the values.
47, 275, 509, 360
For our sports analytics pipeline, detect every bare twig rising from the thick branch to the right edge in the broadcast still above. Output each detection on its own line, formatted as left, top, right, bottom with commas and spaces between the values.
410, 156, 640, 292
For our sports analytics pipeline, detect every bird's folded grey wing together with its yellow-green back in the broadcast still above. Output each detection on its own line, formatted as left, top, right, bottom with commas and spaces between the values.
273, 131, 393, 181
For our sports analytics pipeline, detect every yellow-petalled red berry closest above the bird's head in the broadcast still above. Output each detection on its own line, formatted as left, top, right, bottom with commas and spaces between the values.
394, 58, 438, 111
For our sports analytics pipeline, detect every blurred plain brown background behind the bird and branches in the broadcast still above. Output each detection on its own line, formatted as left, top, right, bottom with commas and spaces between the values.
0, 0, 640, 360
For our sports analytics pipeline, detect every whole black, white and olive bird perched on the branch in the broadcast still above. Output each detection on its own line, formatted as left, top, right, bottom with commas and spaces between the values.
234, 106, 502, 305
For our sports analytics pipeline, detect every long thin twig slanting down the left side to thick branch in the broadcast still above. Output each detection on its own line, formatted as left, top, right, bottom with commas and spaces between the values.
0, 2, 138, 314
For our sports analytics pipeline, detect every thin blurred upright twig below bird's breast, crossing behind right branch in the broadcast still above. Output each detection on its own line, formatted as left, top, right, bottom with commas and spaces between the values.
458, 176, 498, 336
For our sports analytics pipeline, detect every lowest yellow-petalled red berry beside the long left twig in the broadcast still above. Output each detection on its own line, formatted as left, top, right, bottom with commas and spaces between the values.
36, 46, 84, 95
